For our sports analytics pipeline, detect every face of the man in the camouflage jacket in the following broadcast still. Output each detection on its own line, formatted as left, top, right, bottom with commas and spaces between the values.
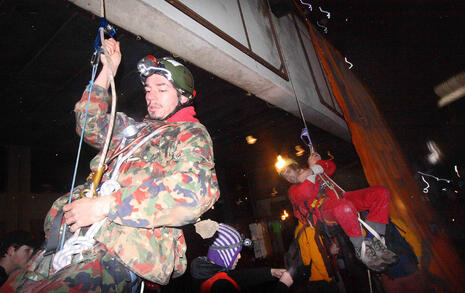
145, 74, 187, 120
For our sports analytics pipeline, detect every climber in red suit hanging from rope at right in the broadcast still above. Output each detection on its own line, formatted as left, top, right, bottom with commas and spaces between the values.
276, 152, 398, 271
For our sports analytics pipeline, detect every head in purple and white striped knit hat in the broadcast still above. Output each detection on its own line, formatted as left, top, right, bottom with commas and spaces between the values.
207, 224, 243, 270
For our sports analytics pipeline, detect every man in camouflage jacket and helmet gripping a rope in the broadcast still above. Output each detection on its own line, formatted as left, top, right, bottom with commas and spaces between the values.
0, 39, 219, 292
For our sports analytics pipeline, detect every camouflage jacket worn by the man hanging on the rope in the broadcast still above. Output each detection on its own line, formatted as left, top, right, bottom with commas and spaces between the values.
75, 86, 219, 284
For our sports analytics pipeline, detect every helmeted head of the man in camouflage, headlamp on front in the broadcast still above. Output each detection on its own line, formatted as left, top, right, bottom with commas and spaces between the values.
137, 55, 196, 120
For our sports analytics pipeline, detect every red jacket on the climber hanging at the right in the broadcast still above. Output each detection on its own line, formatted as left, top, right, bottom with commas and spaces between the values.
289, 160, 337, 224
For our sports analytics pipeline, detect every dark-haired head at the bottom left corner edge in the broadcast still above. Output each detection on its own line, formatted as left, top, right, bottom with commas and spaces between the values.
0, 231, 35, 274
